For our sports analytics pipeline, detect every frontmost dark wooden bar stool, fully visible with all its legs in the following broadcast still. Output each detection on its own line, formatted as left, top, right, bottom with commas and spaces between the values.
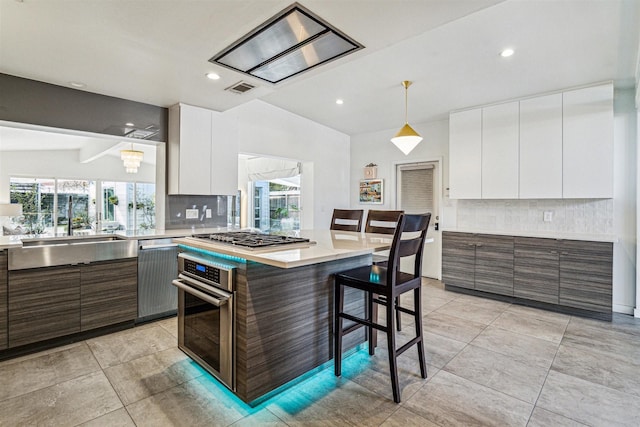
334, 214, 431, 403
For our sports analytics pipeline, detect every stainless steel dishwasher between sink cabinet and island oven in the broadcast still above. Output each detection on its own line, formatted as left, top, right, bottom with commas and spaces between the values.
137, 239, 178, 322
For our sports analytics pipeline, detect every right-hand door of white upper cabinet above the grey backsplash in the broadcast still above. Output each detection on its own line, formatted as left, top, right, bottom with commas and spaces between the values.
210, 112, 238, 195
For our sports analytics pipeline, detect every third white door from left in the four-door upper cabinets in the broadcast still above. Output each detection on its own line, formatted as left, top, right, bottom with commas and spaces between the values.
520, 93, 562, 199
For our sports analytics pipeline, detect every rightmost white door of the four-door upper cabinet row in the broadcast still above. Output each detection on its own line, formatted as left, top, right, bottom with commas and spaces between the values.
562, 84, 613, 198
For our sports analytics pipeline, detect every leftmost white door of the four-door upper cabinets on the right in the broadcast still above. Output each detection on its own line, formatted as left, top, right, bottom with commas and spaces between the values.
449, 109, 482, 199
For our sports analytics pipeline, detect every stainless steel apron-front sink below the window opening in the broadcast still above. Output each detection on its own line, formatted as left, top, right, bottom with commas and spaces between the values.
9, 236, 138, 270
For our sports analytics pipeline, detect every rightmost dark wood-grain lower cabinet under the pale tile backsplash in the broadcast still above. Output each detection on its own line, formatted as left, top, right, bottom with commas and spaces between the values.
559, 240, 613, 313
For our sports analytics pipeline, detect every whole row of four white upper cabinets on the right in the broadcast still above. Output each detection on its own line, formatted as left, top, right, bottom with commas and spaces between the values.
449, 83, 613, 199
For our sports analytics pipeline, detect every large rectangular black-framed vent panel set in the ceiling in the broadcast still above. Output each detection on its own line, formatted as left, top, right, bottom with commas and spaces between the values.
209, 3, 364, 83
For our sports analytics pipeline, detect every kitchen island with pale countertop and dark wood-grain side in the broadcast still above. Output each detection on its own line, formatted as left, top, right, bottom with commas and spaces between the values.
175, 230, 391, 404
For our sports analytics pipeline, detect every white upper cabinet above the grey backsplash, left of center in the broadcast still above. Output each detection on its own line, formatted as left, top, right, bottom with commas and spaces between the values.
167, 104, 238, 195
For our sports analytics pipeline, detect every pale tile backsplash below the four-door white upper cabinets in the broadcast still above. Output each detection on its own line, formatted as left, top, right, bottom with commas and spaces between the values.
455, 199, 613, 234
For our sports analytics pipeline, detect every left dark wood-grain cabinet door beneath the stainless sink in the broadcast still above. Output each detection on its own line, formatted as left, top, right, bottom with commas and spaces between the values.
8, 266, 80, 347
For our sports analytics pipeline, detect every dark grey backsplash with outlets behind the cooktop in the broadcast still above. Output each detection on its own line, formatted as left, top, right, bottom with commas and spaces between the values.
165, 196, 230, 230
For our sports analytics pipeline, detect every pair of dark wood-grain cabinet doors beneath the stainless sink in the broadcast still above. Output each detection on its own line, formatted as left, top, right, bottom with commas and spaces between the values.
6, 258, 138, 347
